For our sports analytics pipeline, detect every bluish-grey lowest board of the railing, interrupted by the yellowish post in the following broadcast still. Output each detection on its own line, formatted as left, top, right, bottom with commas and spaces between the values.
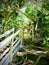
0, 38, 21, 65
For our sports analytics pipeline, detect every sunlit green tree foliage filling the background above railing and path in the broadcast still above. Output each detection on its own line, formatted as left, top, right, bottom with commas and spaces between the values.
0, 0, 49, 45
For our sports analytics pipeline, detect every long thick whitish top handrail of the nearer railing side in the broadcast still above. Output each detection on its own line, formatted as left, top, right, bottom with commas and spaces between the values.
0, 30, 21, 49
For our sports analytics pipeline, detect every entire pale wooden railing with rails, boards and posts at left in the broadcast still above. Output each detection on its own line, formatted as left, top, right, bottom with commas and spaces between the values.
0, 28, 22, 65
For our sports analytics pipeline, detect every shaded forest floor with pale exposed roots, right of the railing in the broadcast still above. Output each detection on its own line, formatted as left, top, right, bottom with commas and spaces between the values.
13, 35, 49, 65
